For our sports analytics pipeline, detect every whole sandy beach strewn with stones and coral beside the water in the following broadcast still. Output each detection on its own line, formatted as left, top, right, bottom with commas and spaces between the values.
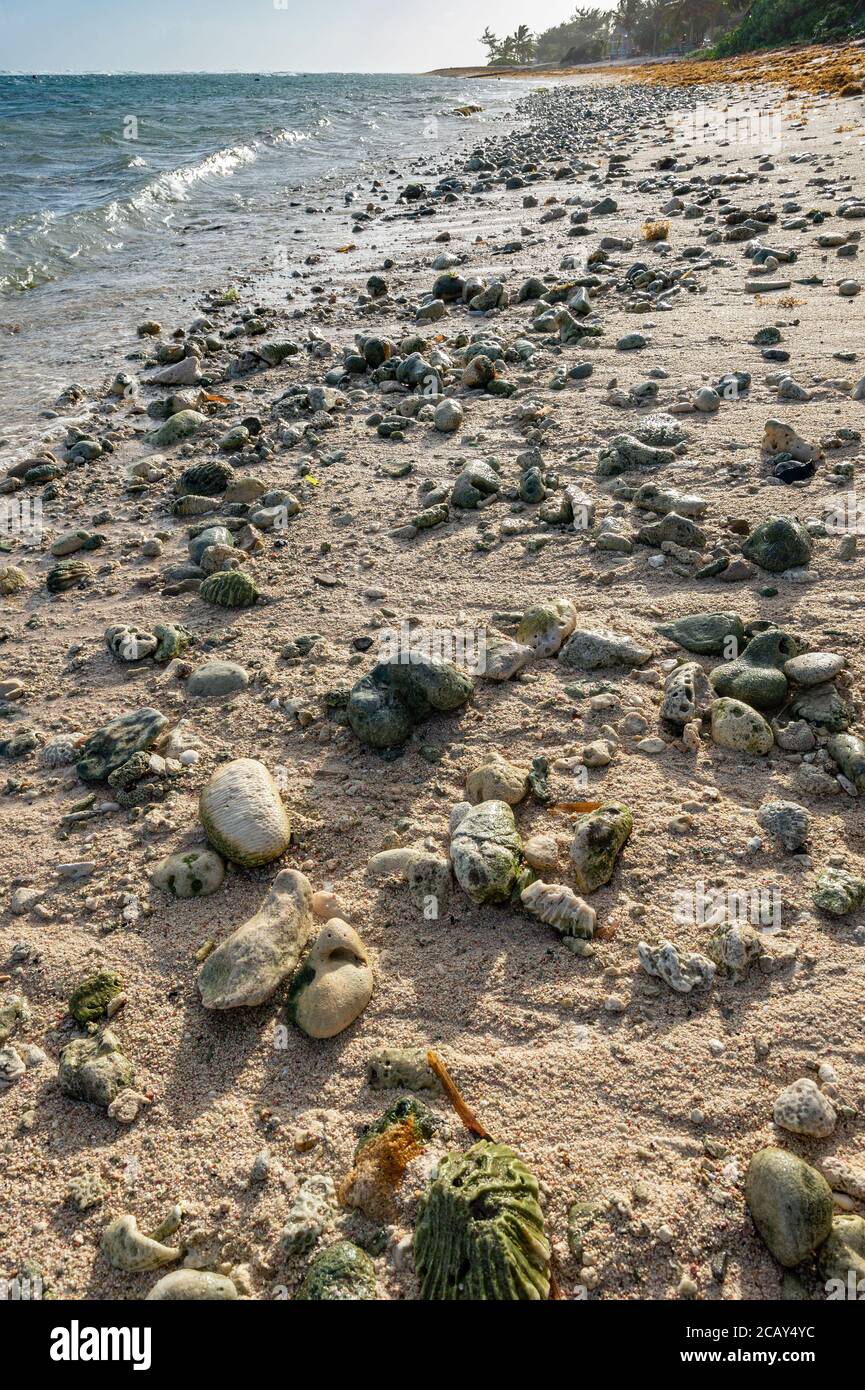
0, 67, 865, 1300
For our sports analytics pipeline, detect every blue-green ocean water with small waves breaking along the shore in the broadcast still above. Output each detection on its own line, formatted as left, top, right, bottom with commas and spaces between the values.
0, 72, 526, 438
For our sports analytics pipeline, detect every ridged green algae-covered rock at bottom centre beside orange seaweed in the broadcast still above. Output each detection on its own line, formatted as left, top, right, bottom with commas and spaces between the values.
414, 1140, 549, 1302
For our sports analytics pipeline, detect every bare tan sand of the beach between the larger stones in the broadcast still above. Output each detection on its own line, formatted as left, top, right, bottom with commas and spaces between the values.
0, 67, 865, 1301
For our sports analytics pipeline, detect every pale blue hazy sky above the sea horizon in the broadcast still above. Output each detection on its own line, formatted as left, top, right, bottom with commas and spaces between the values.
0, 0, 615, 72
